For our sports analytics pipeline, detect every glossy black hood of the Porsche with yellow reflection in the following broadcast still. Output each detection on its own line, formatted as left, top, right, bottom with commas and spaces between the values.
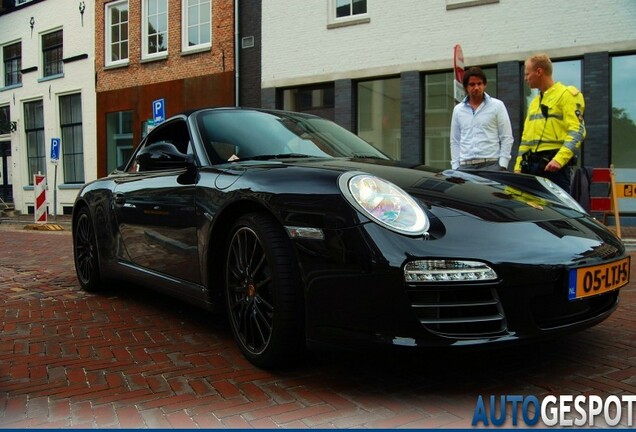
236, 158, 581, 222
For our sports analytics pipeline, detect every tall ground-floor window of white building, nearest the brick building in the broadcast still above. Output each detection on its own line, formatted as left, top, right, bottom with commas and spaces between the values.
60, 93, 84, 183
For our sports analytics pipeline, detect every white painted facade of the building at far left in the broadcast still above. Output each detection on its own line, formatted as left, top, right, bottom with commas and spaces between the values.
0, 0, 97, 215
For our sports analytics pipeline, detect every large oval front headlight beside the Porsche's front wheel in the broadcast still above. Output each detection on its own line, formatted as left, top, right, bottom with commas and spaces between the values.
338, 172, 430, 235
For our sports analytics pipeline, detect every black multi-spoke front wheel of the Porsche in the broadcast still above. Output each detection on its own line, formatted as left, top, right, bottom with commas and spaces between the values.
225, 213, 304, 368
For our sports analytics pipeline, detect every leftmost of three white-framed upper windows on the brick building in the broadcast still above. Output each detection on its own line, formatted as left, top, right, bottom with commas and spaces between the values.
105, 0, 128, 66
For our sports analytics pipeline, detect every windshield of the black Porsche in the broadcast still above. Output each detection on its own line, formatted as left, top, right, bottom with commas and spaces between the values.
197, 109, 389, 163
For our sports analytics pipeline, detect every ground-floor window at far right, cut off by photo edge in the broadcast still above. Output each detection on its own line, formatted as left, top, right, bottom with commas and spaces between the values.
611, 55, 636, 168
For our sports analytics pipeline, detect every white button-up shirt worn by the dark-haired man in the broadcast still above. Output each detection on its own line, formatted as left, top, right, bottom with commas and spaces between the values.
450, 93, 514, 169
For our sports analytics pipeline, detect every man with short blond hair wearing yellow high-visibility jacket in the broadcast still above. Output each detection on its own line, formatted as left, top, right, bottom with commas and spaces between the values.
514, 54, 586, 192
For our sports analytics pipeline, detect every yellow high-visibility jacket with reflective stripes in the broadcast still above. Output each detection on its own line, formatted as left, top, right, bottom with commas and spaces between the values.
515, 82, 585, 171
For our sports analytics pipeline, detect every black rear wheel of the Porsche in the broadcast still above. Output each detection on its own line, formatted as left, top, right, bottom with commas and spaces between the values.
73, 207, 102, 291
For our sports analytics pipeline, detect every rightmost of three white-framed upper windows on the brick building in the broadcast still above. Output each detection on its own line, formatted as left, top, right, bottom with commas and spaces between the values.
182, 0, 212, 51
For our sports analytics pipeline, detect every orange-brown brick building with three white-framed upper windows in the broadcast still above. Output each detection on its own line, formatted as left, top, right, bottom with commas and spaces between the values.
95, 0, 235, 175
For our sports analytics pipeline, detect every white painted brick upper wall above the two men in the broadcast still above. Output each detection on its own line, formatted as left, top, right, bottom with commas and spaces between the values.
262, 0, 636, 88
